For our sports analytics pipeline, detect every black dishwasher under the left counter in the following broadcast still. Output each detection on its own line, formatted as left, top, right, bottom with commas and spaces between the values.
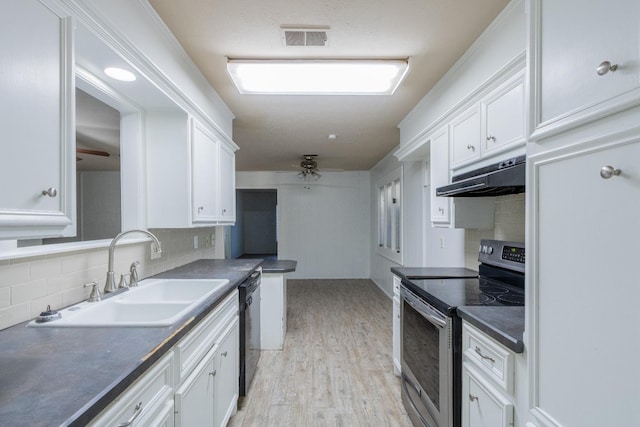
238, 271, 261, 396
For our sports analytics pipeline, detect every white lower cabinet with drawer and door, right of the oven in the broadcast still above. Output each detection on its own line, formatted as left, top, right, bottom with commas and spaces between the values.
462, 322, 515, 427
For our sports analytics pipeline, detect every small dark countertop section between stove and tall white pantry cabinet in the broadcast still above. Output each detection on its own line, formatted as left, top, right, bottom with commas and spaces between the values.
457, 307, 524, 353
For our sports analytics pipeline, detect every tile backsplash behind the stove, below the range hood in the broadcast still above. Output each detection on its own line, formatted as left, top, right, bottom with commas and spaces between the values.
464, 193, 525, 270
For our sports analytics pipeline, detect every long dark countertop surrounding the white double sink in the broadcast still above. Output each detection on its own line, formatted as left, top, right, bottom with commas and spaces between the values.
0, 260, 262, 427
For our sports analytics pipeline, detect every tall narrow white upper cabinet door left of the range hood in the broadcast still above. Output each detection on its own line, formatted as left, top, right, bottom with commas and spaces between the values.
430, 127, 451, 226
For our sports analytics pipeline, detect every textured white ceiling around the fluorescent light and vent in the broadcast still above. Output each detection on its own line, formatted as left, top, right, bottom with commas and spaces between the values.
149, 0, 508, 171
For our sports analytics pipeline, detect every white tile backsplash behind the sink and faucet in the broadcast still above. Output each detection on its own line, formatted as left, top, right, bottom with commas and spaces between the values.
0, 227, 222, 329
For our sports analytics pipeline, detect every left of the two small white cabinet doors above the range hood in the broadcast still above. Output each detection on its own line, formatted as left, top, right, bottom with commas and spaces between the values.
451, 105, 481, 167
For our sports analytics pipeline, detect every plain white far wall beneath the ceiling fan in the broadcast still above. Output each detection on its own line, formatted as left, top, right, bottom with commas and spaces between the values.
236, 172, 370, 279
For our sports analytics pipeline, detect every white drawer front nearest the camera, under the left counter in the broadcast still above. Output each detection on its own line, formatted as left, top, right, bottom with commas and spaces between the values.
89, 352, 173, 426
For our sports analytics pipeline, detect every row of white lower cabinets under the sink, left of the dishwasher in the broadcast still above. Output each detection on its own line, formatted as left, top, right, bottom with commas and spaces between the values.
90, 291, 240, 427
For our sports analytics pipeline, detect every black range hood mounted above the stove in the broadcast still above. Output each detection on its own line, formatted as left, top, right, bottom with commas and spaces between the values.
436, 156, 526, 197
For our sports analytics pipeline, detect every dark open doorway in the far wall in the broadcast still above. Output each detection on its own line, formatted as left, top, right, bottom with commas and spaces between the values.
230, 189, 278, 259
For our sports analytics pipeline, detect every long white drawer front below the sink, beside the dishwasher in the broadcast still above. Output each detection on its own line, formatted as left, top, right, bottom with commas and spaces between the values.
175, 290, 238, 381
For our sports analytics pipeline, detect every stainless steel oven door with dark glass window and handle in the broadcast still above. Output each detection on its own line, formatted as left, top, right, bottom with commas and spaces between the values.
401, 285, 453, 427
